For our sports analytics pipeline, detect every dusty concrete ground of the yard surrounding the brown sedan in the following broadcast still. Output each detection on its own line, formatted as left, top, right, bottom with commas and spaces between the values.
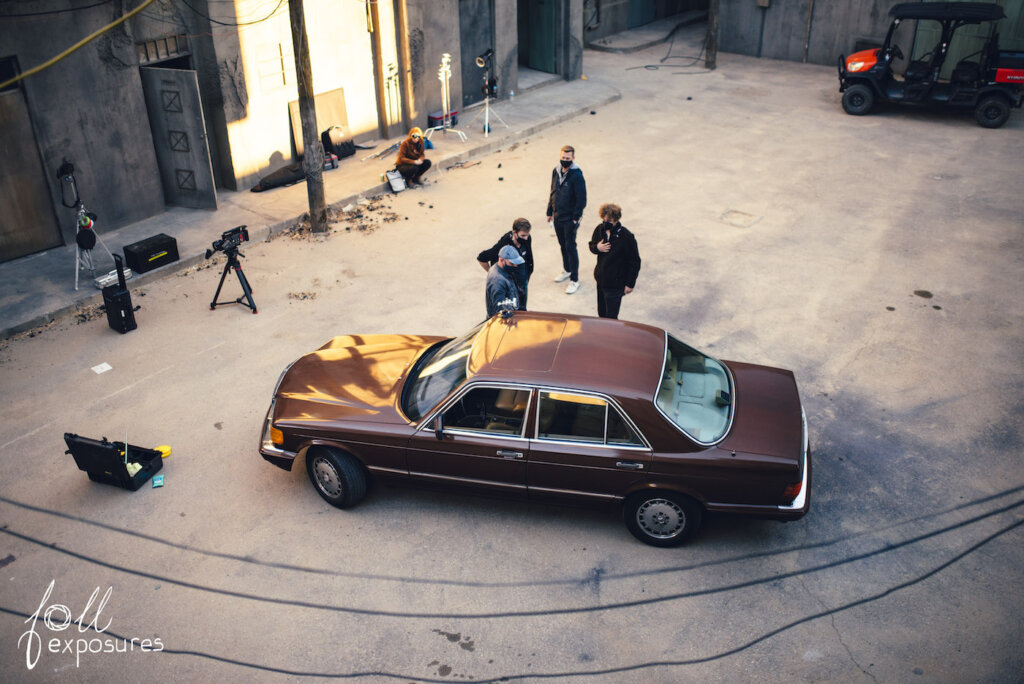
0, 21, 1024, 683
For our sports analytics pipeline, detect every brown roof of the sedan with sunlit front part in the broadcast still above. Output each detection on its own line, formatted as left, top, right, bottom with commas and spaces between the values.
468, 311, 666, 398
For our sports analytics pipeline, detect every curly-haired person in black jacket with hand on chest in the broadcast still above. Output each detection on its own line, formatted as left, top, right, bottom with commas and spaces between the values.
590, 204, 640, 318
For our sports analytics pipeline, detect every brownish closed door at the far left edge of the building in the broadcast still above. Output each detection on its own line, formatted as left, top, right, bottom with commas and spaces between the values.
0, 87, 62, 261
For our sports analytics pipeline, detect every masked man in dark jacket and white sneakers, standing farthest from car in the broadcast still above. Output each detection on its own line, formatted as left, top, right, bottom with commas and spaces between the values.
547, 145, 587, 295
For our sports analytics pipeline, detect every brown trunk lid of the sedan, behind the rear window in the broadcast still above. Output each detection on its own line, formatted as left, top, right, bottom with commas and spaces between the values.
719, 361, 804, 463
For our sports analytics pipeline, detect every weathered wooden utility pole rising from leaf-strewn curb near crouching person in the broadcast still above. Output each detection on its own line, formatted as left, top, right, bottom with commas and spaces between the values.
288, 0, 327, 232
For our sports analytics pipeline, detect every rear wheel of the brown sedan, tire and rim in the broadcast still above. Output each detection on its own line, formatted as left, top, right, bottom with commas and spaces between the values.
623, 491, 702, 547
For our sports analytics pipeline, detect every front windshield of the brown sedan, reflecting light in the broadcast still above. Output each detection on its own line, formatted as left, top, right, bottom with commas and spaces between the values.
401, 324, 483, 423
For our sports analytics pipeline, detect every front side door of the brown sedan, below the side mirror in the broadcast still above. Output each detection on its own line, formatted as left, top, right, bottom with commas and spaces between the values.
406, 383, 531, 494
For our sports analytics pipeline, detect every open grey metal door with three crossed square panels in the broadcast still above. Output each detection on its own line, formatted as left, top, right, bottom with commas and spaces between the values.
139, 67, 217, 209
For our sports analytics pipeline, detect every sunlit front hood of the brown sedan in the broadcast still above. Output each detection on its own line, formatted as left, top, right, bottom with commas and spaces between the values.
274, 335, 444, 423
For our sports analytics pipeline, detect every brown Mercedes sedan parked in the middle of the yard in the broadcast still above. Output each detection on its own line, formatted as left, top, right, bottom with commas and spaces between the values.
260, 311, 811, 546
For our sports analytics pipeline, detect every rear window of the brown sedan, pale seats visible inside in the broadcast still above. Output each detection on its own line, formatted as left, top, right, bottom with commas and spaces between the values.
657, 335, 732, 444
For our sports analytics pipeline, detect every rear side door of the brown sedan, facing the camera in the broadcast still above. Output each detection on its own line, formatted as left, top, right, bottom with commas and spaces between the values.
526, 390, 651, 500
